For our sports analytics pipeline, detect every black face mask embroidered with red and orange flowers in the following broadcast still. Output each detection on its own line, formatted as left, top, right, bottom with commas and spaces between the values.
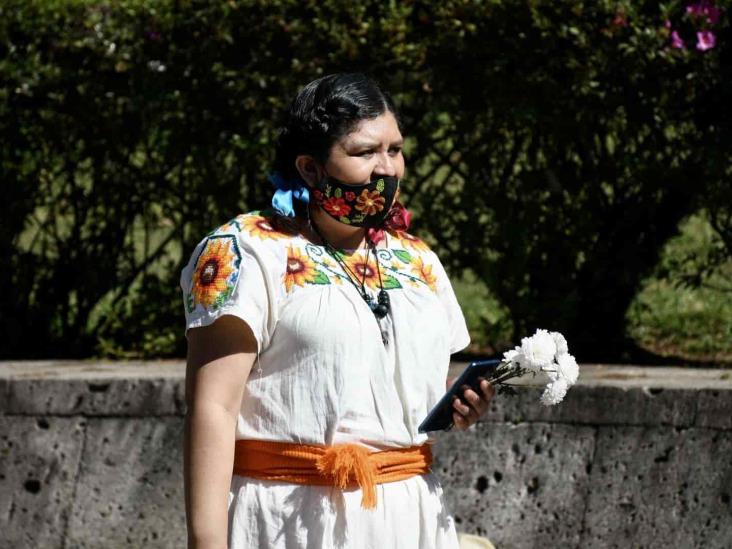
312, 175, 399, 227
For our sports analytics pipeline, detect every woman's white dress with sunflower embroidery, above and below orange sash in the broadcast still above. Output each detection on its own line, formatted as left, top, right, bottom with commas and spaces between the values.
181, 212, 469, 549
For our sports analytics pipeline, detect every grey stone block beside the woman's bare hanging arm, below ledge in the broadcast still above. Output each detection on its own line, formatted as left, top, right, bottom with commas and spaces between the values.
67, 418, 186, 548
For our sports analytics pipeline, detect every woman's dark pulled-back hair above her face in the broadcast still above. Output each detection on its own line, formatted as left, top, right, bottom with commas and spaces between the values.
274, 73, 398, 179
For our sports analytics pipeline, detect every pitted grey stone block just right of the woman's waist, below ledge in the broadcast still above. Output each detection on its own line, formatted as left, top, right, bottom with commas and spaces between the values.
435, 423, 594, 548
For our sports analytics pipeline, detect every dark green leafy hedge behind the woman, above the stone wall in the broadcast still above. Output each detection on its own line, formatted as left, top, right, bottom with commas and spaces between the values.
0, 0, 732, 360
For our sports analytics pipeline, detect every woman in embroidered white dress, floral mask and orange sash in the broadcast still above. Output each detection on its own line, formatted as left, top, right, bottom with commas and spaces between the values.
181, 74, 493, 549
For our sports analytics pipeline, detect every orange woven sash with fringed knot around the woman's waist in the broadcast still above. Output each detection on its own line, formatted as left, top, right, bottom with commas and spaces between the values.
234, 440, 432, 509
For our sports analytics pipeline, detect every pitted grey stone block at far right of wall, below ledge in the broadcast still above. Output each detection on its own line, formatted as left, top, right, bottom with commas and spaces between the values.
581, 427, 732, 549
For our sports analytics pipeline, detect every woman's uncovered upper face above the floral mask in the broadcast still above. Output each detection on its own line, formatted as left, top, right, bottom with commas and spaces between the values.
325, 111, 404, 185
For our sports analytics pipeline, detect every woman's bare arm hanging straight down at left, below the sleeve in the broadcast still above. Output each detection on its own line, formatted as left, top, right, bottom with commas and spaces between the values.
184, 316, 257, 549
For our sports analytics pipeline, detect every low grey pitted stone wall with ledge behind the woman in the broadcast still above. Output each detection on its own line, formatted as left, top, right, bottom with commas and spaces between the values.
0, 362, 732, 549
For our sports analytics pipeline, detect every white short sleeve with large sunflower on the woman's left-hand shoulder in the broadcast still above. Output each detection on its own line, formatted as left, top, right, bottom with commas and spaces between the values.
180, 232, 276, 351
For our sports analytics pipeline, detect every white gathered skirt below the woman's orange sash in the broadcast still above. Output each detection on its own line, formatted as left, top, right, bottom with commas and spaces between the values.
229, 474, 459, 549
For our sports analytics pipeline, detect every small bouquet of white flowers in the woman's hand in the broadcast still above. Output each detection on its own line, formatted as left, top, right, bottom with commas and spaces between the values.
487, 330, 579, 406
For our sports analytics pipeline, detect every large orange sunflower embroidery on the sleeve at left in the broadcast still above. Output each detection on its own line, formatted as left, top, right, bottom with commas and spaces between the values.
190, 235, 241, 309
